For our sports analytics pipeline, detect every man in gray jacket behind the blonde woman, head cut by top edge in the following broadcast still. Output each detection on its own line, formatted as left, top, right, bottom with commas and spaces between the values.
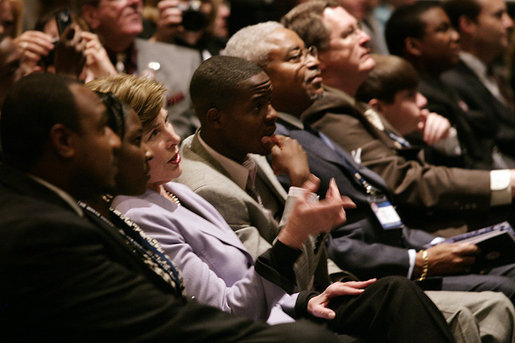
78, 0, 201, 137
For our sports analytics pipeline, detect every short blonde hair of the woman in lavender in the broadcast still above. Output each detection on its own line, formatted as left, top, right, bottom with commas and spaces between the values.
86, 74, 166, 129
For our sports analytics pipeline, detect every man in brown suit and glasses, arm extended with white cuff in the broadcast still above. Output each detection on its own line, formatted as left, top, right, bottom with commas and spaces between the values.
282, 1, 515, 235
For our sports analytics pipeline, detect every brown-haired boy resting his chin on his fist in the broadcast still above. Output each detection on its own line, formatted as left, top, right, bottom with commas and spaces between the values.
356, 55, 463, 167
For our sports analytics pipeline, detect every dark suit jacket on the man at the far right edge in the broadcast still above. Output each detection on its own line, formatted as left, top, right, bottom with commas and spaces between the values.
442, 61, 515, 156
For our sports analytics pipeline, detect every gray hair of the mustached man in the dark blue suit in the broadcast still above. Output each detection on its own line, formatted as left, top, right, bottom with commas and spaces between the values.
224, 21, 284, 67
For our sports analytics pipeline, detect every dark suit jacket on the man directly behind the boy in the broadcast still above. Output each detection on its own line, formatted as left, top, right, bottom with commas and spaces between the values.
419, 74, 496, 169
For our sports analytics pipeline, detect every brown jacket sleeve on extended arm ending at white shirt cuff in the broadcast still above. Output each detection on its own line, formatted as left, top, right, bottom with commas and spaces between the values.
315, 114, 490, 210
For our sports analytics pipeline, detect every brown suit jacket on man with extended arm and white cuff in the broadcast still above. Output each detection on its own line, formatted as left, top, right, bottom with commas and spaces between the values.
302, 89, 505, 234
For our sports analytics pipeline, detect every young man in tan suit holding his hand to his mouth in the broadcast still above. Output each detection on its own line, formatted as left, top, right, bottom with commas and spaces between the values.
177, 57, 339, 290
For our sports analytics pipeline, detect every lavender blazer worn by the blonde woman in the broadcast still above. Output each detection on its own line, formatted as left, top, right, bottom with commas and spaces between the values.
113, 182, 297, 323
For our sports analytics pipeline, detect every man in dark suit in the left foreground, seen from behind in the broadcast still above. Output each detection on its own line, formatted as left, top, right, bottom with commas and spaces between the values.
0, 74, 346, 342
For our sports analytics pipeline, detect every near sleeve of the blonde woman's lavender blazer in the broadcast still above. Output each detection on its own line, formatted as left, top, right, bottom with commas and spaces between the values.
118, 204, 292, 319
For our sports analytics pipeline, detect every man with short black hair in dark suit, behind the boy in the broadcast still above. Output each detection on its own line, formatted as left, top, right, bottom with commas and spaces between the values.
385, 2, 511, 169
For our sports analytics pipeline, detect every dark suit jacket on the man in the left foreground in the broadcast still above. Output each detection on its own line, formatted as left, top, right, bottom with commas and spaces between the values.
0, 165, 274, 342
